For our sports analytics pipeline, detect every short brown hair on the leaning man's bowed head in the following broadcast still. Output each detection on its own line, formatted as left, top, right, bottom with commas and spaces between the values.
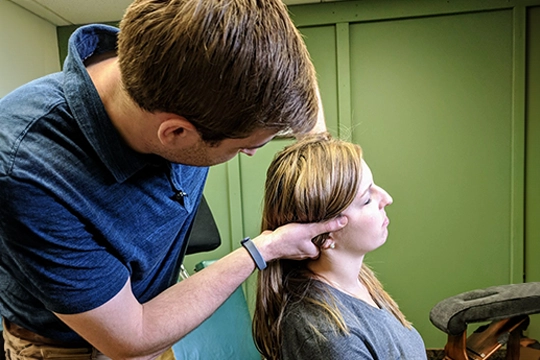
118, 0, 318, 142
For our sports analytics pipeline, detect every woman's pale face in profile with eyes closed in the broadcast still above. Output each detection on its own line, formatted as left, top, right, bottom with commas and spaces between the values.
332, 160, 392, 255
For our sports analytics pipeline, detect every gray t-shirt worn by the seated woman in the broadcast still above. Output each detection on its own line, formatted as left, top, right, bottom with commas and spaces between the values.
281, 287, 427, 360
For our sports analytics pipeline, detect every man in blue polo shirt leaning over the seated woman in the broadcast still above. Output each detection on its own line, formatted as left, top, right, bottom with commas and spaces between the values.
0, 0, 346, 359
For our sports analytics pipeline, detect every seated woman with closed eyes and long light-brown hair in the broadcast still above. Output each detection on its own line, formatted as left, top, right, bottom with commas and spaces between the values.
253, 134, 426, 360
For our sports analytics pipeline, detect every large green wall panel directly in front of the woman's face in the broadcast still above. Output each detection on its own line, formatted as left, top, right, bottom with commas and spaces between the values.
350, 11, 512, 347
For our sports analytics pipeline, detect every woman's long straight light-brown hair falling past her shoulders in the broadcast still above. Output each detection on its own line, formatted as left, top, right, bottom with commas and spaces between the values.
253, 134, 410, 360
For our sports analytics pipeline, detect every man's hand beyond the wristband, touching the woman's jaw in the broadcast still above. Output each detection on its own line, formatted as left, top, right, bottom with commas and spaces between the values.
253, 216, 348, 262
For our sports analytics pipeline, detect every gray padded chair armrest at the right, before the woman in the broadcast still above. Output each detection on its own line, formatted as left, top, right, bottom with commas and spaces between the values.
429, 282, 540, 335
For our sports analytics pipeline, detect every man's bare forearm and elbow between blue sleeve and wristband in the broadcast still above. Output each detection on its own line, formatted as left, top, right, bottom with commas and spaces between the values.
57, 248, 255, 359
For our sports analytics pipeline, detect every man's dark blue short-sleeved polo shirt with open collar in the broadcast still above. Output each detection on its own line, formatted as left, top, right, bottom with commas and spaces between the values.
0, 25, 208, 341
